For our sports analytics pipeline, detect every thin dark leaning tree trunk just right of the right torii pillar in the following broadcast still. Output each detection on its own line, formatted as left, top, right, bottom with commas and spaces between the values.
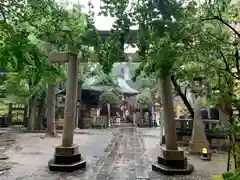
171, 76, 194, 118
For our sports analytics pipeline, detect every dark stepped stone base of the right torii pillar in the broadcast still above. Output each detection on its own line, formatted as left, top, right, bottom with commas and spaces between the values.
152, 147, 194, 175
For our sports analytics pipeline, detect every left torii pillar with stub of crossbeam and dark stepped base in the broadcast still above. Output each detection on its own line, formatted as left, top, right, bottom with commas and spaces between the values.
48, 52, 86, 172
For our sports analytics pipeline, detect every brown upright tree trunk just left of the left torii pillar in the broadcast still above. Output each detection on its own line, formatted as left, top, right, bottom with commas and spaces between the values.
46, 84, 56, 137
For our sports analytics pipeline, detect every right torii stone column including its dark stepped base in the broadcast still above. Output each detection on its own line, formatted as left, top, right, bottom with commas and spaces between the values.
152, 76, 193, 174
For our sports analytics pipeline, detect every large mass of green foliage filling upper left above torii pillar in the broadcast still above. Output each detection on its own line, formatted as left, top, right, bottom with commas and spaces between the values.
0, 0, 100, 102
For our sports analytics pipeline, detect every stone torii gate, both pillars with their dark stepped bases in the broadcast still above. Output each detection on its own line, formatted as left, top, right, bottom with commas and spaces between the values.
48, 29, 193, 174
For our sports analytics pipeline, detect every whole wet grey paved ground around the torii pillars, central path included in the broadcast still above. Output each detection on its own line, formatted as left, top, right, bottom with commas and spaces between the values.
0, 127, 226, 180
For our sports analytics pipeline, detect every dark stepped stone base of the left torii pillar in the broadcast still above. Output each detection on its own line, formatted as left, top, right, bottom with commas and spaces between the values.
48, 145, 86, 172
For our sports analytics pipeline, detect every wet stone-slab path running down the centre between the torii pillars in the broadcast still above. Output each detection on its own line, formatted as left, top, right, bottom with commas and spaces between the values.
96, 128, 149, 180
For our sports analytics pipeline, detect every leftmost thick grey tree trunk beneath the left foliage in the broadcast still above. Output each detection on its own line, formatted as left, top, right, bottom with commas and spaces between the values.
27, 96, 37, 131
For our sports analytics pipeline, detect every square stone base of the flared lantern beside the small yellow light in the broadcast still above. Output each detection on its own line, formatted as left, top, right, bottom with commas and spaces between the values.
188, 141, 211, 155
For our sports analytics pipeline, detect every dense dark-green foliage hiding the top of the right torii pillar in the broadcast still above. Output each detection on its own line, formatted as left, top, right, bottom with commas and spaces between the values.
132, 0, 198, 76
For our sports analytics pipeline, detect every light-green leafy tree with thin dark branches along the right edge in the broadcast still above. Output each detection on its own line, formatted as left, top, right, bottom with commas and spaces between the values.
172, 0, 239, 170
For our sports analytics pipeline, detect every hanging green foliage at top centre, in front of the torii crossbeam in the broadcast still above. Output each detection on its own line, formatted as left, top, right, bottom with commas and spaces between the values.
96, 0, 131, 74
